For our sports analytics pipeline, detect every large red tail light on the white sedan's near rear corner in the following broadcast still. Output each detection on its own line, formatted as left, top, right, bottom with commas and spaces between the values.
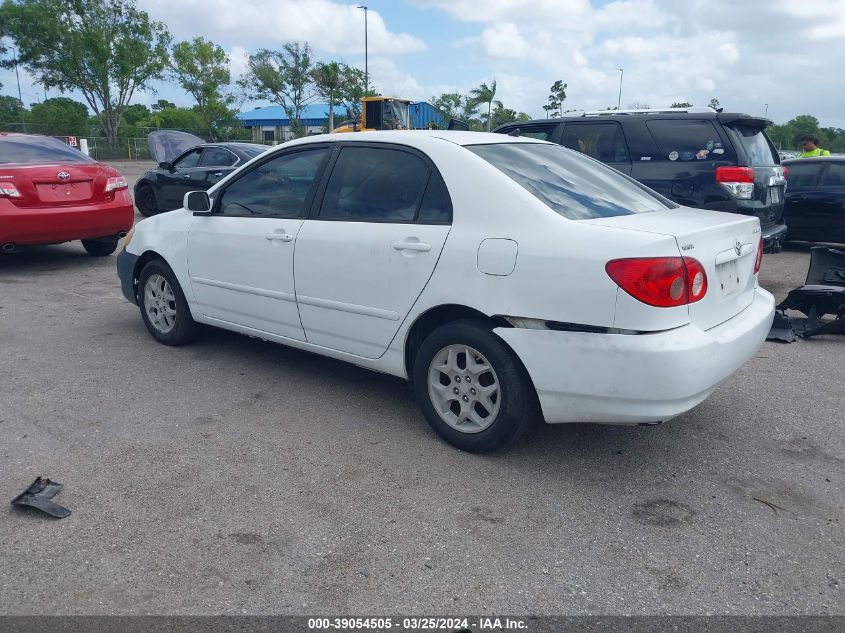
604, 257, 707, 308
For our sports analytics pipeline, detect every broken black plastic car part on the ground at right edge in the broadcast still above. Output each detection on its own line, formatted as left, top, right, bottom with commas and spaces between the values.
767, 246, 845, 343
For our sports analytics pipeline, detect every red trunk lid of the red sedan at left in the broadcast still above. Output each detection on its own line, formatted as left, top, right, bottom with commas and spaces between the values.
0, 163, 120, 209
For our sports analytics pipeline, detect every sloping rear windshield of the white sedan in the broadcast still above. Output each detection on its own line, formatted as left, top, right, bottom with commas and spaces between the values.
466, 143, 675, 220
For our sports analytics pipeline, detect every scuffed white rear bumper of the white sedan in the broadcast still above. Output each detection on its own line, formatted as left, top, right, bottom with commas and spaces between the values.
495, 288, 774, 424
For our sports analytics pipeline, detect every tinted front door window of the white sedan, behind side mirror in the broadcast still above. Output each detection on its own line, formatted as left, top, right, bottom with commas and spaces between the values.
218, 148, 329, 218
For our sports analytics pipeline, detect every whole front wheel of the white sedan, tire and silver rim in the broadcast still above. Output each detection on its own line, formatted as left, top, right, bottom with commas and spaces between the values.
138, 260, 200, 345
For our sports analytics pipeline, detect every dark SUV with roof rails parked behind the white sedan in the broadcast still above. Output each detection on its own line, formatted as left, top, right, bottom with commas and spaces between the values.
494, 108, 786, 252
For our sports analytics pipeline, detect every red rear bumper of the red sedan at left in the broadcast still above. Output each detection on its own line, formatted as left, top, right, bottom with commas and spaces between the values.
0, 189, 135, 244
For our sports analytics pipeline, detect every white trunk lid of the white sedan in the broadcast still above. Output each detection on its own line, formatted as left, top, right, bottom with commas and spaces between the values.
582, 207, 760, 330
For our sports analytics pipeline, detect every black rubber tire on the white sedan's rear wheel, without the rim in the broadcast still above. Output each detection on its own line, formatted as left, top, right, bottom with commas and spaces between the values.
413, 319, 540, 453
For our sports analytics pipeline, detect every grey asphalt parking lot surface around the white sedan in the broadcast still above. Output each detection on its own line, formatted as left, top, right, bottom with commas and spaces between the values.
0, 160, 845, 615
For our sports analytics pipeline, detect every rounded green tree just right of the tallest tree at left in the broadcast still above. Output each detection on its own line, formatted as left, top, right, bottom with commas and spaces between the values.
170, 37, 235, 136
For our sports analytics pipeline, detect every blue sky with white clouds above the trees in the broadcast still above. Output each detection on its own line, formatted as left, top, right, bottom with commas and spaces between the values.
0, 0, 845, 128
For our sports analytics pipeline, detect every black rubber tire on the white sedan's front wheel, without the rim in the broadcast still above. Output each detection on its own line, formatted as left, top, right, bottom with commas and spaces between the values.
138, 259, 200, 346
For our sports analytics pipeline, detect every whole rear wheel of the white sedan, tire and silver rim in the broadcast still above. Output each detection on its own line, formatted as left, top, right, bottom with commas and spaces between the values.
413, 320, 538, 453
